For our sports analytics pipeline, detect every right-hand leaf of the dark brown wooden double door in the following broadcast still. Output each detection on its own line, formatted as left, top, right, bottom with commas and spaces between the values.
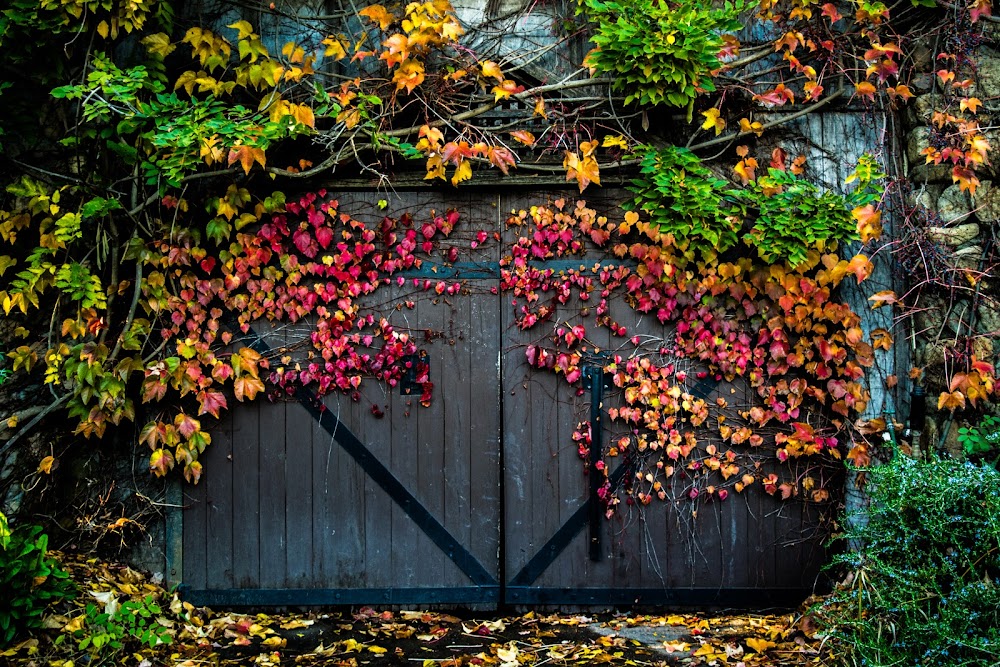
502, 190, 824, 606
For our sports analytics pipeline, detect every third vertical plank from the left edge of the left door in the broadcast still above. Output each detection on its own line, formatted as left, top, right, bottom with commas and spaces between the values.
232, 403, 261, 588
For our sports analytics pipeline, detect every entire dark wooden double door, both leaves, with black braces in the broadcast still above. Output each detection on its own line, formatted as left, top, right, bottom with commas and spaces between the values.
178, 191, 823, 606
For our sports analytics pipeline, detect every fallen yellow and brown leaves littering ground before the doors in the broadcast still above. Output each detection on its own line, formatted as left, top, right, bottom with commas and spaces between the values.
0, 554, 833, 667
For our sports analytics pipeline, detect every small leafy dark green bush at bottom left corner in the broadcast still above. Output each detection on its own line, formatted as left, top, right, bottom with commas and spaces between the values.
0, 526, 75, 644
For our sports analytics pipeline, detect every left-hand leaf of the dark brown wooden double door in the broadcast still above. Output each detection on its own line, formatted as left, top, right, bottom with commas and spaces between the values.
180, 193, 500, 605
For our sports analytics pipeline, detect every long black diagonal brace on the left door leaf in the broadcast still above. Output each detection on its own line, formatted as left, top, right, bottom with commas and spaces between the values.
236, 329, 498, 586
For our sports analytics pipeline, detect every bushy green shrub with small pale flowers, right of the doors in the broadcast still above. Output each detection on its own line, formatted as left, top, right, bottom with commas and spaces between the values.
819, 457, 1000, 667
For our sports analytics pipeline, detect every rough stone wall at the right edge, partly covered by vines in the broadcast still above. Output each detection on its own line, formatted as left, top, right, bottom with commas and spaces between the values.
893, 39, 1000, 456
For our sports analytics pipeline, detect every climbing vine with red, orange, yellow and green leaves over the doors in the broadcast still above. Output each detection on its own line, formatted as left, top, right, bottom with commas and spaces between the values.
0, 0, 996, 544
